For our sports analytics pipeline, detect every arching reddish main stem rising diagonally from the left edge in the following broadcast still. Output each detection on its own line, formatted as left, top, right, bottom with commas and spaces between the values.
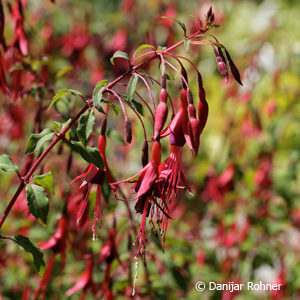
0, 30, 202, 230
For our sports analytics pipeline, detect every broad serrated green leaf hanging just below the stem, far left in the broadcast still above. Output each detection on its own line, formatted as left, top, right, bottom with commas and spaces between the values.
26, 184, 49, 227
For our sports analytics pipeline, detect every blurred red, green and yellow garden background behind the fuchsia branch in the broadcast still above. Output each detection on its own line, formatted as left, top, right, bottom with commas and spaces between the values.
0, 0, 300, 300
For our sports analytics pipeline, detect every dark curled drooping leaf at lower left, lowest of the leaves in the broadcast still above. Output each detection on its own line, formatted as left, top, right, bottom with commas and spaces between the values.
10, 234, 45, 276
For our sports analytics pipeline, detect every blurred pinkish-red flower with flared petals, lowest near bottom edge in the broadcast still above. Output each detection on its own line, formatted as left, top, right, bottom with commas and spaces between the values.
66, 255, 97, 300
